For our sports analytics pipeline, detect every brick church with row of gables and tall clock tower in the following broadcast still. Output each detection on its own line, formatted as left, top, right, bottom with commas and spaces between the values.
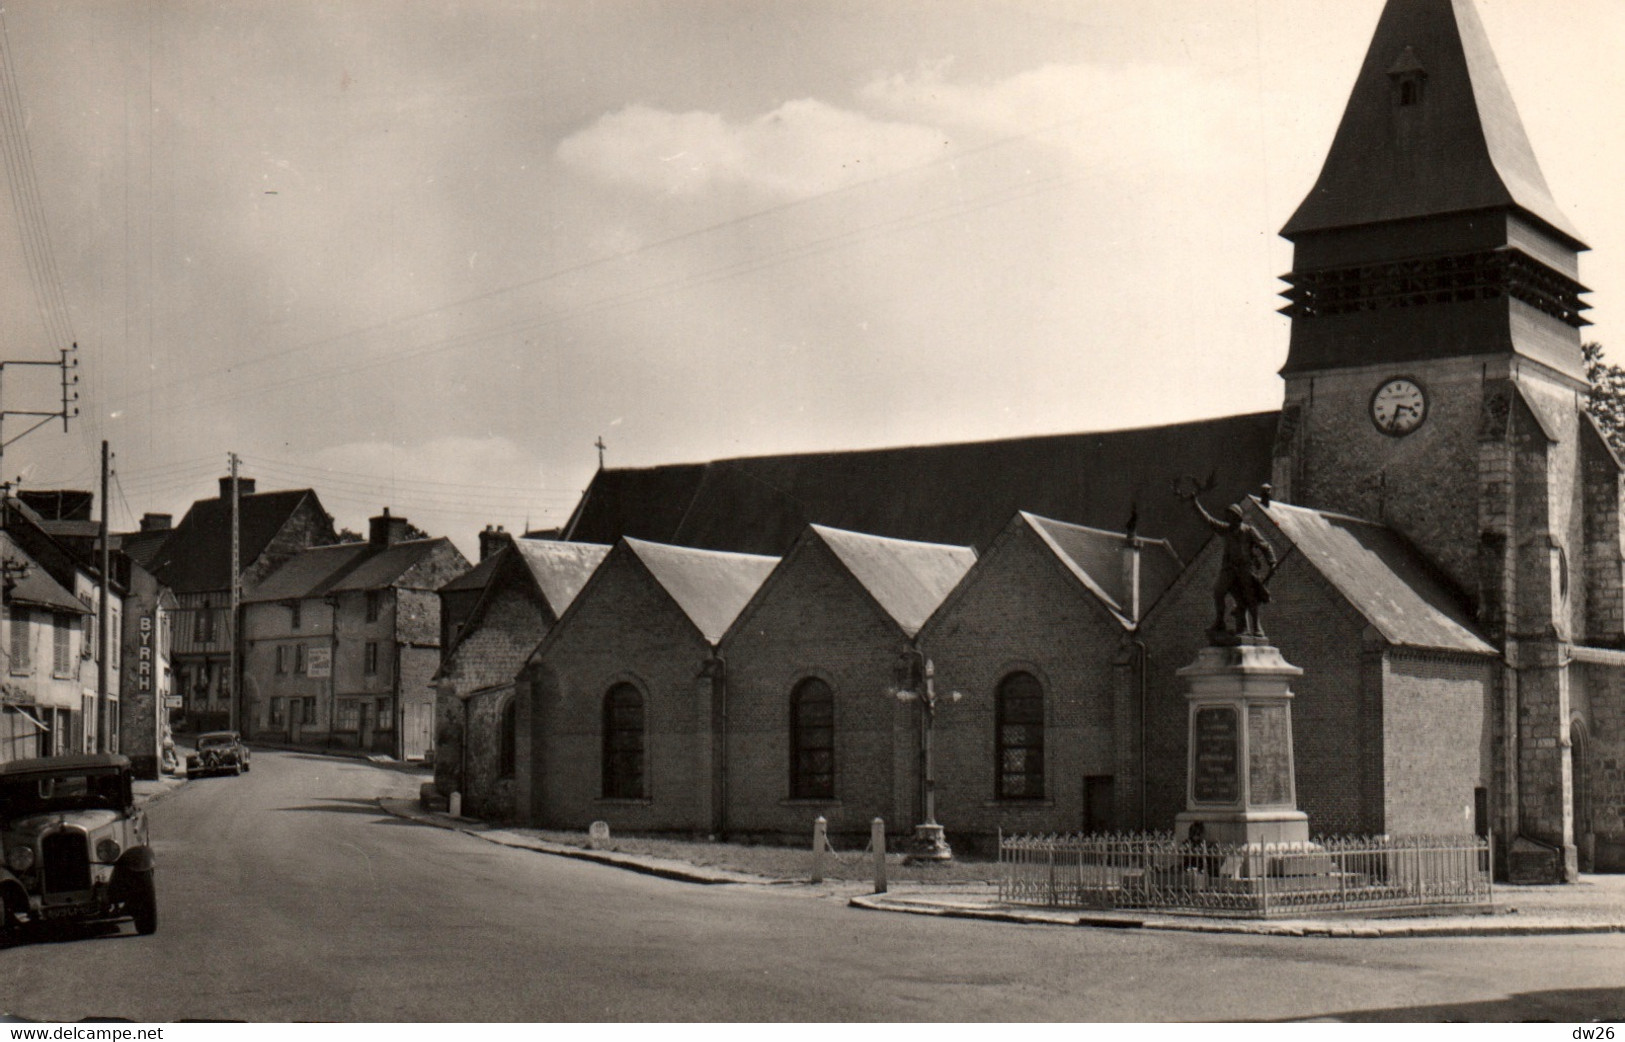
494, 0, 1625, 881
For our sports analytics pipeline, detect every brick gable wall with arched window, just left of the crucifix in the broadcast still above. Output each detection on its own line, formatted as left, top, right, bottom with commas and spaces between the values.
722, 538, 916, 839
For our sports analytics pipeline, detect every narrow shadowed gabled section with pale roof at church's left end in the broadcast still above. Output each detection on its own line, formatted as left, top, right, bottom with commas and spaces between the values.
434, 528, 609, 819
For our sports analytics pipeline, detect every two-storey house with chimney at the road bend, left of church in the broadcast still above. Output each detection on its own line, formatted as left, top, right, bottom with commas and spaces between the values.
242, 510, 468, 759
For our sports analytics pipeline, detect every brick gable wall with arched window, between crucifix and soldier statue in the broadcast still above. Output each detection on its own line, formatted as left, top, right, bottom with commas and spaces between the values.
920, 520, 1138, 836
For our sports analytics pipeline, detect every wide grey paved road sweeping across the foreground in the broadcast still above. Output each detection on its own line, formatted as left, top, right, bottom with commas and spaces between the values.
0, 753, 1625, 1021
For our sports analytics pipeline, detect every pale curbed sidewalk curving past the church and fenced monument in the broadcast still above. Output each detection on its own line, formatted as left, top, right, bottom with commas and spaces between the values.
379, 800, 1625, 938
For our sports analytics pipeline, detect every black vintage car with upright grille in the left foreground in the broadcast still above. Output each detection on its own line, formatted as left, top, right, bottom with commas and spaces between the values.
0, 753, 158, 936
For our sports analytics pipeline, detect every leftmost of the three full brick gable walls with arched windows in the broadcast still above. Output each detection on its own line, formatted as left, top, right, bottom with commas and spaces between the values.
533, 546, 710, 832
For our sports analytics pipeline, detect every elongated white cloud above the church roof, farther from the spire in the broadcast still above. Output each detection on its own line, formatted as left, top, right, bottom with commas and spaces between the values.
557, 98, 951, 198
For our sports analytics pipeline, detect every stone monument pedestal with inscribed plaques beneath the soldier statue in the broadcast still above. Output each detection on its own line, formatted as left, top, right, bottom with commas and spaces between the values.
1175, 642, 1310, 851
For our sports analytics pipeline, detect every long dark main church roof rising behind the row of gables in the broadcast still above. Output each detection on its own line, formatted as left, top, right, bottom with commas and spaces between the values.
569, 413, 1279, 559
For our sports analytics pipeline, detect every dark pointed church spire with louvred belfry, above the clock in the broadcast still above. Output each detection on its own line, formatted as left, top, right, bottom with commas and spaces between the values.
1281, 0, 1588, 384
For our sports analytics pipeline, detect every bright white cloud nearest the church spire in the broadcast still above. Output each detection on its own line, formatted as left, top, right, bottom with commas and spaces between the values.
860, 60, 1256, 166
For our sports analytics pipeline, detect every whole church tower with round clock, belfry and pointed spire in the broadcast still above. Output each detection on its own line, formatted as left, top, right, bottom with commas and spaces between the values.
1274, 0, 1625, 863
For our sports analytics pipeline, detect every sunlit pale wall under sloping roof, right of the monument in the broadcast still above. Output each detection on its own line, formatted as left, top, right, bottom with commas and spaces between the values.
1383, 649, 1497, 836
